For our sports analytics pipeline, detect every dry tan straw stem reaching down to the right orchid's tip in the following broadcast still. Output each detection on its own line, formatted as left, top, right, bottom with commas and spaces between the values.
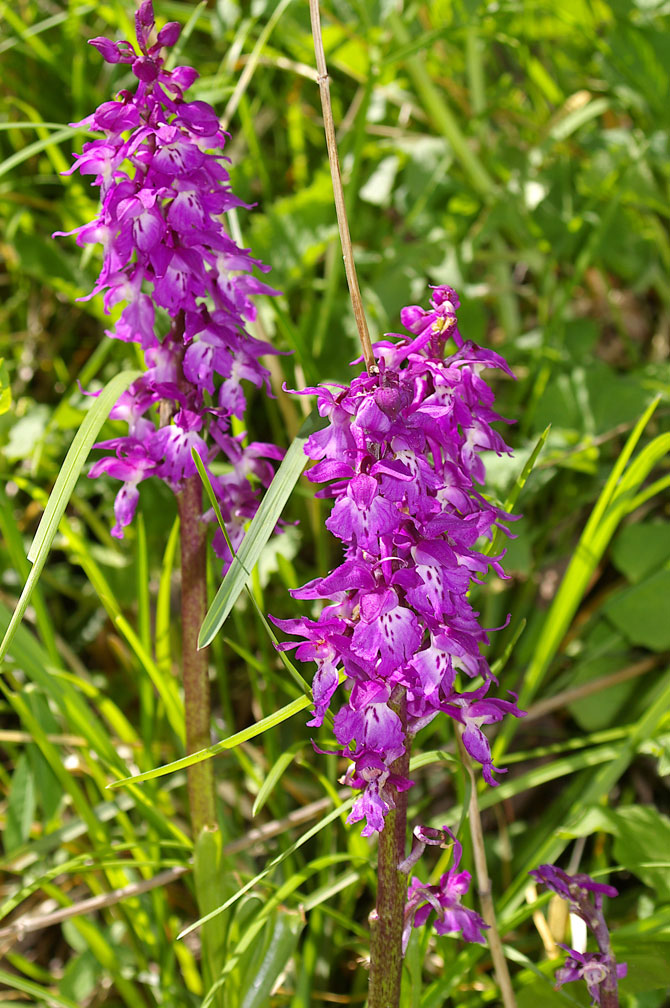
309, 0, 377, 372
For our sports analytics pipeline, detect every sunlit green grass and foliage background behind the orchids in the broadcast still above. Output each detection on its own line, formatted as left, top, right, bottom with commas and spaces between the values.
0, 0, 670, 1008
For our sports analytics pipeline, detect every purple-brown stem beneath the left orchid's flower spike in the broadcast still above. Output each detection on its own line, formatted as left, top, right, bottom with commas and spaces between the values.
177, 476, 217, 838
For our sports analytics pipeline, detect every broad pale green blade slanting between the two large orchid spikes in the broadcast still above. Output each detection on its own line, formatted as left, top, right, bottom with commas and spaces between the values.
197, 413, 325, 647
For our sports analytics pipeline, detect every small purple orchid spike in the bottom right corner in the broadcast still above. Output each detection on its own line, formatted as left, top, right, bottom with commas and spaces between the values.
530, 865, 628, 1008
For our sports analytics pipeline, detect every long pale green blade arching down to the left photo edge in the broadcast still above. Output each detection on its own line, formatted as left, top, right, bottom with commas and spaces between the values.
0, 371, 141, 659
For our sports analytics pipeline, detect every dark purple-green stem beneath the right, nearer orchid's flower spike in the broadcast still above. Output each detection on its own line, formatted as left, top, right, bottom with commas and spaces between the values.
368, 691, 410, 1008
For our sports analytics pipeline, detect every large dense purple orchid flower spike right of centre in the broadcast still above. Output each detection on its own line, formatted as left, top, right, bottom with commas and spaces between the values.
274, 286, 521, 836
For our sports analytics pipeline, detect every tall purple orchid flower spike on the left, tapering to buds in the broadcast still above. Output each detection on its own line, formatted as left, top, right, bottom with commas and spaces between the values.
57, 0, 282, 562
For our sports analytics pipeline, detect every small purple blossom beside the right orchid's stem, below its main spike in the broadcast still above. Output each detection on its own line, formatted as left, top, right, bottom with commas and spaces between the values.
403, 827, 489, 954
